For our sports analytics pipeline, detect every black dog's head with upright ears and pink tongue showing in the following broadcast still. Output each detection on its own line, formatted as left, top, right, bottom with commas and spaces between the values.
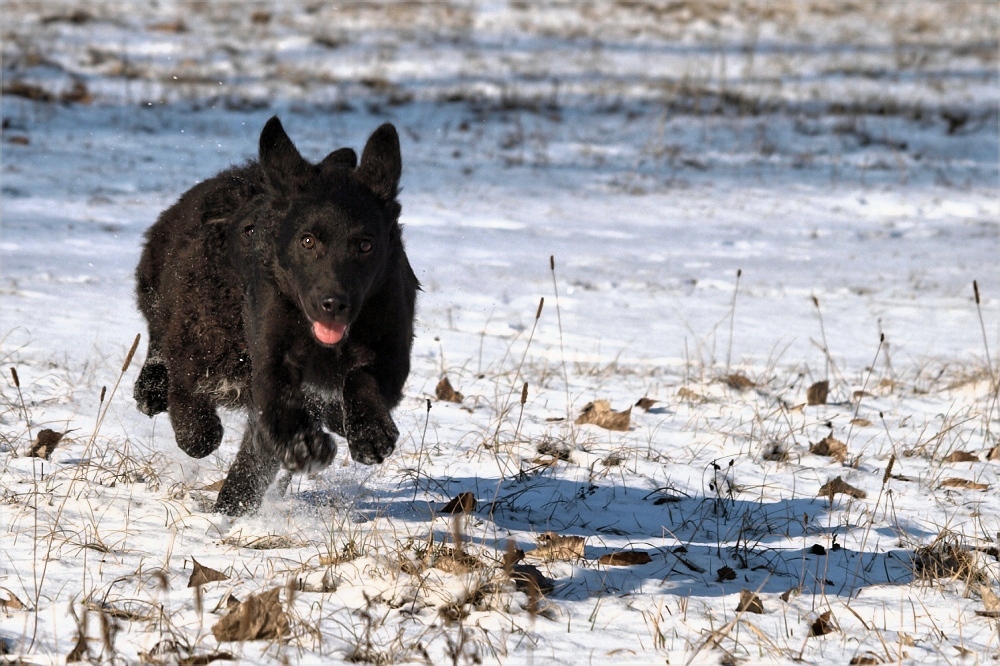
252, 117, 402, 347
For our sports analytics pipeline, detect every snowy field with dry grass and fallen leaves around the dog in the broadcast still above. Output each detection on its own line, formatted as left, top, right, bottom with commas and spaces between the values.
0, 0, 1000, 666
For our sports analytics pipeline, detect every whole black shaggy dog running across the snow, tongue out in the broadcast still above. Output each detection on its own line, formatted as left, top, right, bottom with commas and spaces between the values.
135, 118, 419, 515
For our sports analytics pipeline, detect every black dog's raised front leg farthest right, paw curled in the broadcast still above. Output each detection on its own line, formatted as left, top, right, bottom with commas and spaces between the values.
344, 370, 399, 465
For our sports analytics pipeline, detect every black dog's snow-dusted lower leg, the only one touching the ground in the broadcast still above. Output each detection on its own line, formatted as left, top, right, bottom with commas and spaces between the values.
215, 417, 281, 516
